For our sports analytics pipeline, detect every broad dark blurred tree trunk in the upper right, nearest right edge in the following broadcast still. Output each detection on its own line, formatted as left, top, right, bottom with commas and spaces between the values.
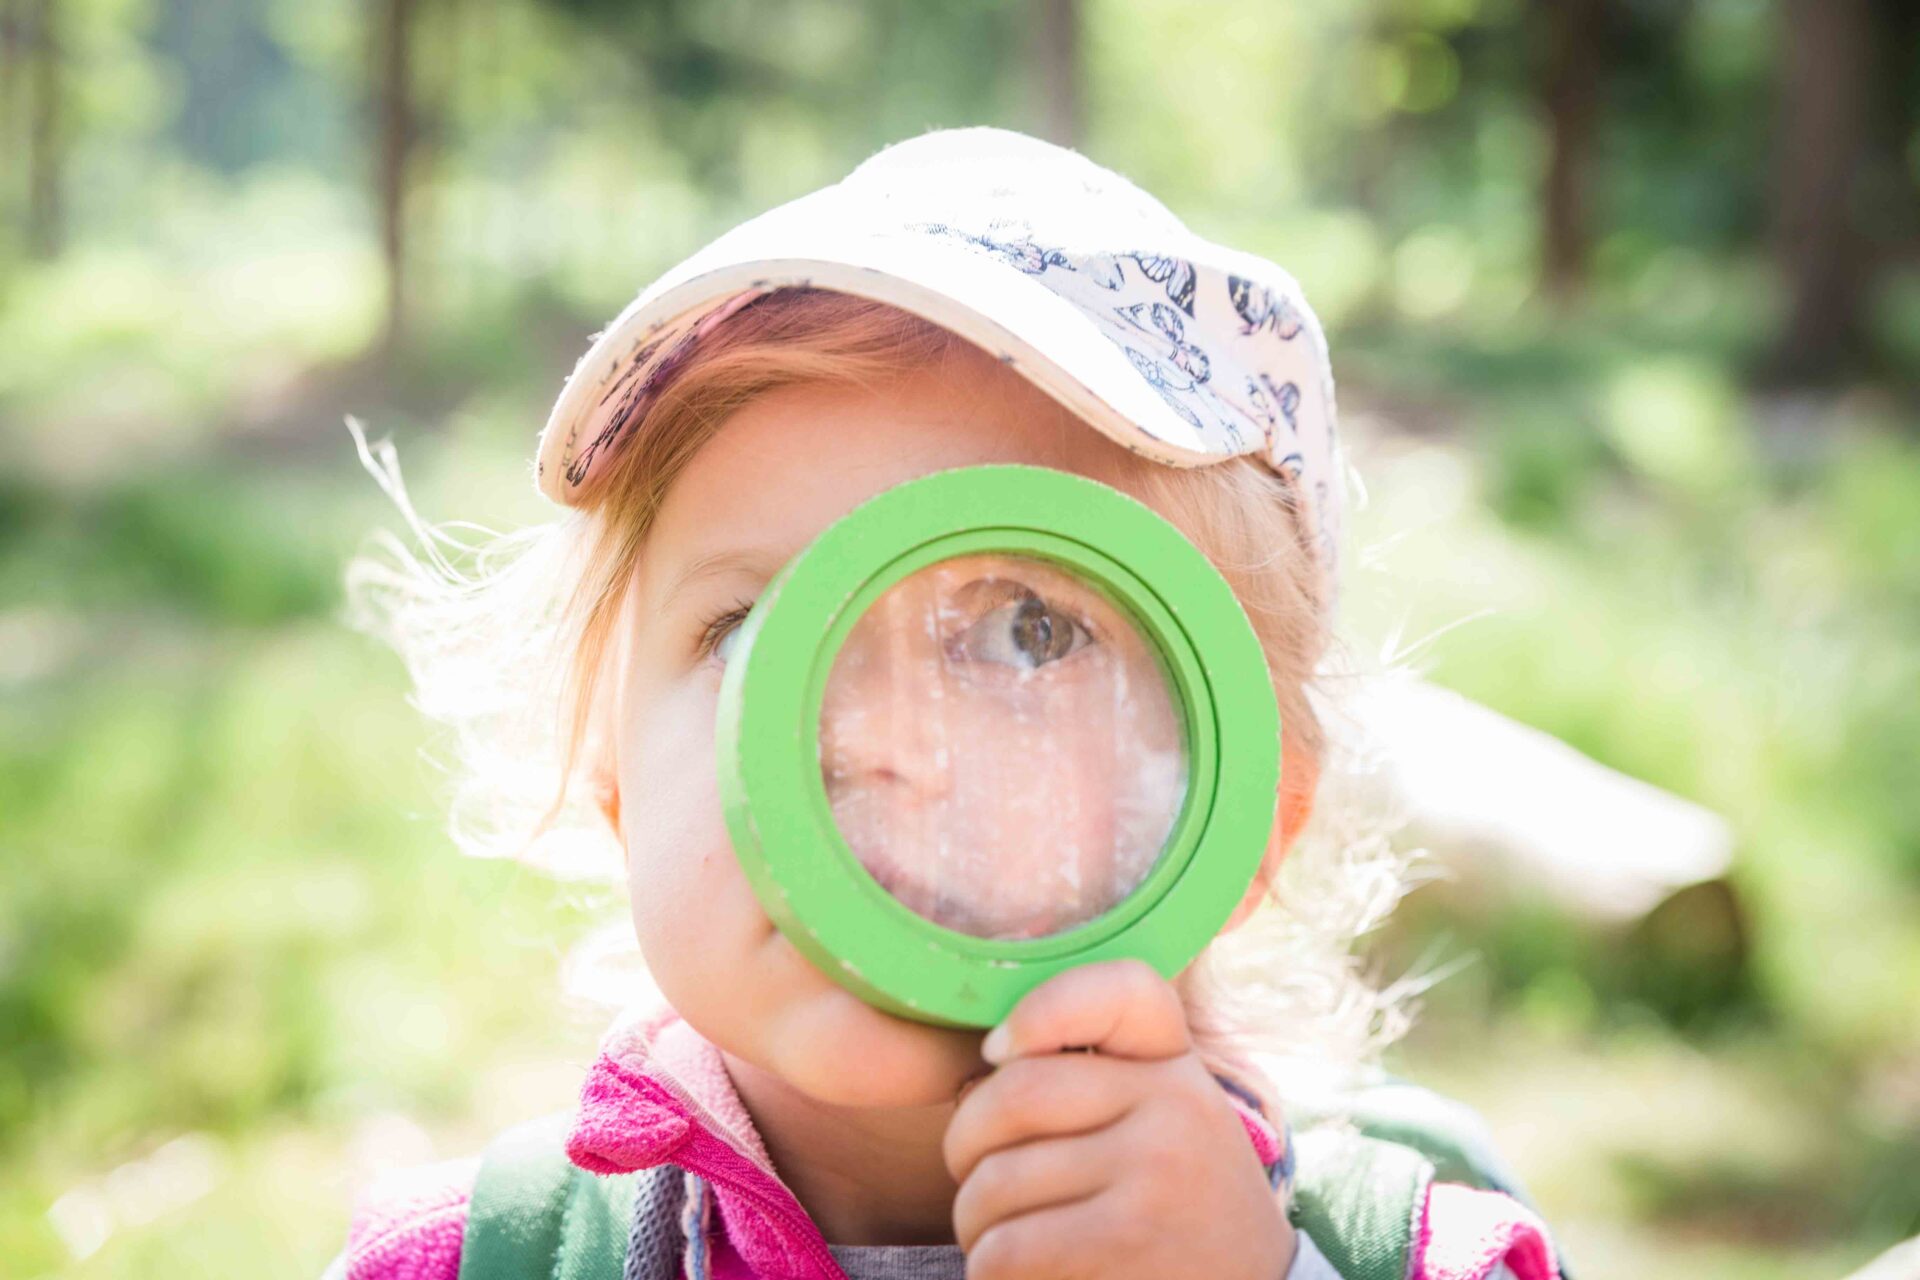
1766, 0, 1876, 382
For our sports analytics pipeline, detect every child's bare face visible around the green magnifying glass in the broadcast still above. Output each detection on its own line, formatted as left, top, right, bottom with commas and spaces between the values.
618, 349, 1182, 1107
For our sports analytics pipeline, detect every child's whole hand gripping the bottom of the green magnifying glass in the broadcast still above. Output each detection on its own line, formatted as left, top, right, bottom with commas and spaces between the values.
943, 960, 1294, 1280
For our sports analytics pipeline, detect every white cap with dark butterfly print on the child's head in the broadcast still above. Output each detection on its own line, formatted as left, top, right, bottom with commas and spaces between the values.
536, 129, 1342, 587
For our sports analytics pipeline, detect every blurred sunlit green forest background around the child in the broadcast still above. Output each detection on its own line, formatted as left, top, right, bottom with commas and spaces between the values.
0, 0, 1920, 1278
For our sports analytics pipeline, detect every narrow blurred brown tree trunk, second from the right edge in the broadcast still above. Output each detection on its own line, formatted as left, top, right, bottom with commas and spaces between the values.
1536, 0, 1605, 299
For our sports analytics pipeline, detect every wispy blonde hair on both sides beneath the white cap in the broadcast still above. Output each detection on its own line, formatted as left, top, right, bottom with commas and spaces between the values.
348, 290, 1405, 1102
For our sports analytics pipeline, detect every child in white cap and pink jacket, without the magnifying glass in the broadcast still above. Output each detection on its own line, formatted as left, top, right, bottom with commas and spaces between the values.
328, 129, 1559, 1280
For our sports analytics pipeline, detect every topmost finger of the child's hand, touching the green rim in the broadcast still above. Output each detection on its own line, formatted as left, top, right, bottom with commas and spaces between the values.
981, 960, 1192, 1063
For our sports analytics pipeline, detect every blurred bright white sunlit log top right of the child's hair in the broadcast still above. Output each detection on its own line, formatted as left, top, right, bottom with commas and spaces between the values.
1352, 677, 1734, 923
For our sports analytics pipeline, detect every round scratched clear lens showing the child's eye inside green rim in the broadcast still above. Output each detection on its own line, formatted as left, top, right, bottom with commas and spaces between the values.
820, 555, 1187, 938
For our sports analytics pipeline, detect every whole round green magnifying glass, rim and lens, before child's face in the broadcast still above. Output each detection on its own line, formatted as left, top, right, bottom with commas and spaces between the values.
716, 466, 1281, 1027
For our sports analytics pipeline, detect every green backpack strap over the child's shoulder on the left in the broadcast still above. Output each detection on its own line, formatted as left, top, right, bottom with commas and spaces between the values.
459, 1111, 634, 1280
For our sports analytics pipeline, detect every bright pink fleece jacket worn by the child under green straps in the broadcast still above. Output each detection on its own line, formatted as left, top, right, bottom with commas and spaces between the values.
330, 1009, 1557, 1280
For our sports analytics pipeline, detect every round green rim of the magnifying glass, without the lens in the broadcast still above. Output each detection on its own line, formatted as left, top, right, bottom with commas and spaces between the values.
716, 464, 1281, 1027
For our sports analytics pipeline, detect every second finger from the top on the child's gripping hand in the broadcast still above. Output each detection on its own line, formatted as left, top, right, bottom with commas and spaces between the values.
941, 1054, 1158, 1182
